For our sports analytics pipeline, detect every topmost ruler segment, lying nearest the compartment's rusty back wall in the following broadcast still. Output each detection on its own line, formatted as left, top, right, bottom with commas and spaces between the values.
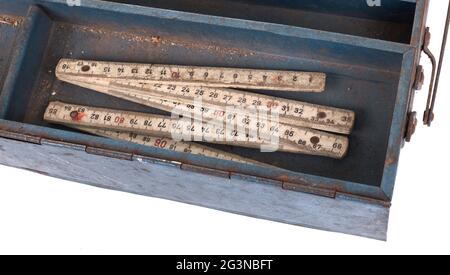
56, 59, 326, 92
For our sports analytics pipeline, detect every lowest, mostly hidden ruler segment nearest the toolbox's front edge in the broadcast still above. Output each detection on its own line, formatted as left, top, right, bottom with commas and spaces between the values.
70, 126, 269, 166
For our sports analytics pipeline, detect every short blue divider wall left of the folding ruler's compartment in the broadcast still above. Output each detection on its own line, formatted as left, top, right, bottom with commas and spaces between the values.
0, 6, 53, 120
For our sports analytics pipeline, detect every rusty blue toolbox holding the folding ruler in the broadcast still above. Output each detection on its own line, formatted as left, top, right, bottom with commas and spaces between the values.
0, 0, 428, 239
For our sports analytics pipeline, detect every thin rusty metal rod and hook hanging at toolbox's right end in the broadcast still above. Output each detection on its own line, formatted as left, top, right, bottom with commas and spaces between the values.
422, 3, 450, 126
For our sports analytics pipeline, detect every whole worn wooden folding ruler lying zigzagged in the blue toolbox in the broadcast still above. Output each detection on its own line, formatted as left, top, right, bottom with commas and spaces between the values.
45, 59, 355, 161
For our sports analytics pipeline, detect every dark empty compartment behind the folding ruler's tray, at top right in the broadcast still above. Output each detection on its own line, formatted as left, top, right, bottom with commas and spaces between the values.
113, 0, 416, 44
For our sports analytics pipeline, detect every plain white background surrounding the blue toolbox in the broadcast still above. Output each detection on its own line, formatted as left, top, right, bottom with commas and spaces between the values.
0, 1, 450, 254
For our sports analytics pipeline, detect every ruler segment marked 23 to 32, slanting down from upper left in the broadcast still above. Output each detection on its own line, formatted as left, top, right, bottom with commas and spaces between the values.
59, 75, 355, 134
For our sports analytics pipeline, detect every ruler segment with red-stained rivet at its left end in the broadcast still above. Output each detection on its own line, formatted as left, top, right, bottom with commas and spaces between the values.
44, 102, 348, 159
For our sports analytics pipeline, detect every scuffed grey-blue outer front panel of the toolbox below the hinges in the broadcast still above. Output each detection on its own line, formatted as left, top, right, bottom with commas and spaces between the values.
0, 138, 389, 240
